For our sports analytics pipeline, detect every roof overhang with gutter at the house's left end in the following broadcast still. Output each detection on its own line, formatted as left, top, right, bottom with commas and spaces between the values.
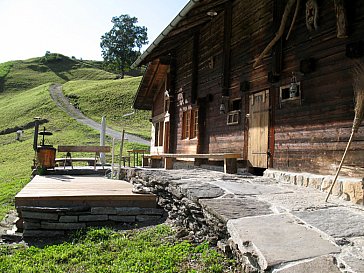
132, 0, 233, 110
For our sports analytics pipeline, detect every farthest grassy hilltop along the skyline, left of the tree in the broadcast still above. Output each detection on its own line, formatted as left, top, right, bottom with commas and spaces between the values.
0, 53, 116, 92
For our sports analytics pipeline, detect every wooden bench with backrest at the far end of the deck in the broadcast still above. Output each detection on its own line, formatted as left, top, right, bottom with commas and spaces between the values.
56, 145, 111, 169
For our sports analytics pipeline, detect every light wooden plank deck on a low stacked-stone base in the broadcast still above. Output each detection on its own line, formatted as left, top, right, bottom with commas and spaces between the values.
15, 175, 156, 208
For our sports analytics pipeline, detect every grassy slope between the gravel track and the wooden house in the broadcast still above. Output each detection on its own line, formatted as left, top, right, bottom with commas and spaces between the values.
63, 77, 151, 138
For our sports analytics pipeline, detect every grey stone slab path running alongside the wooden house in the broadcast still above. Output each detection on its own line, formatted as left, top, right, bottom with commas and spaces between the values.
129, 169, 364, 273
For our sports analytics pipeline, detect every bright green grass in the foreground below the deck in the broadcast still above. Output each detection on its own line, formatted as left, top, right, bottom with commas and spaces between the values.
0, 225, 237, 273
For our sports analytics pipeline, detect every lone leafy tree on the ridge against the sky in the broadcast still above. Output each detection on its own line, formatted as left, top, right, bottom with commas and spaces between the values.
100, 14, 148, 76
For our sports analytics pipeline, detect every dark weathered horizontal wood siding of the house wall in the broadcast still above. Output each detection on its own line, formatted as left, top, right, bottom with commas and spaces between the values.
171, 0, 364, 176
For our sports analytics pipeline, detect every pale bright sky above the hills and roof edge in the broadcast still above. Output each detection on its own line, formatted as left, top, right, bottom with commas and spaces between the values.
0, 0, 188, 63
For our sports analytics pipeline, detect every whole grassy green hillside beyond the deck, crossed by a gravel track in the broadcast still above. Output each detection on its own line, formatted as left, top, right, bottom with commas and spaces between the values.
0, 54, 150, 219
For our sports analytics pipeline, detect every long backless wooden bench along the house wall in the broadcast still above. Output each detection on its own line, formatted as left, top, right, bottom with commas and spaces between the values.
143, 153, 241, 173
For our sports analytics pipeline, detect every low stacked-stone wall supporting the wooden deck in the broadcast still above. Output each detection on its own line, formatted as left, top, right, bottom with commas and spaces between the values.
17, 206, 164, 237
